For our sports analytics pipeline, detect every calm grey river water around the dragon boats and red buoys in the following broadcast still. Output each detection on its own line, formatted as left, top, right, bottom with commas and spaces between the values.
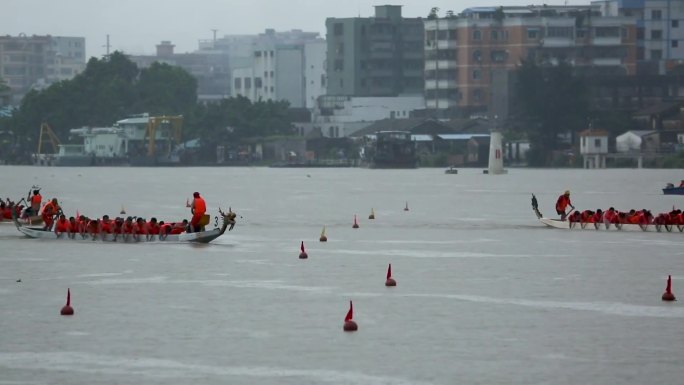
0, 166, 684, 385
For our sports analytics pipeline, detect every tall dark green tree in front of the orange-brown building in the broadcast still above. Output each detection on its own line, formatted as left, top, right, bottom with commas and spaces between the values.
515, 61, 589, 166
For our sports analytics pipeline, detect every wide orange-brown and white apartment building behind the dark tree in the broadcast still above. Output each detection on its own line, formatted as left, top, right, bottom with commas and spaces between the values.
425, 4, 637, 117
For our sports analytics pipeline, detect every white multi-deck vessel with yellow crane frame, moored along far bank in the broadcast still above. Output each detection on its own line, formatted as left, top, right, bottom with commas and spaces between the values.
51, 114, 183, 166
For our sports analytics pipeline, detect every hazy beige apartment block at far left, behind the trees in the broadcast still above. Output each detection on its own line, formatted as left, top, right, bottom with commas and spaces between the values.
0, 35, 86, 105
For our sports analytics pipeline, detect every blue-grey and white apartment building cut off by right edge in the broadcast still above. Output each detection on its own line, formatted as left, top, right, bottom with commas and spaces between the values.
592, 0, 684, 75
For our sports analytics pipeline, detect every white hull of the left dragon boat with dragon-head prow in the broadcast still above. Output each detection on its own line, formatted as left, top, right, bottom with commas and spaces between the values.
12, 209, 236, 243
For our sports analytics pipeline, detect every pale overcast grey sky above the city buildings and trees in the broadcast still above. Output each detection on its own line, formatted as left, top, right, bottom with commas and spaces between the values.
0, 0, 590, 57
